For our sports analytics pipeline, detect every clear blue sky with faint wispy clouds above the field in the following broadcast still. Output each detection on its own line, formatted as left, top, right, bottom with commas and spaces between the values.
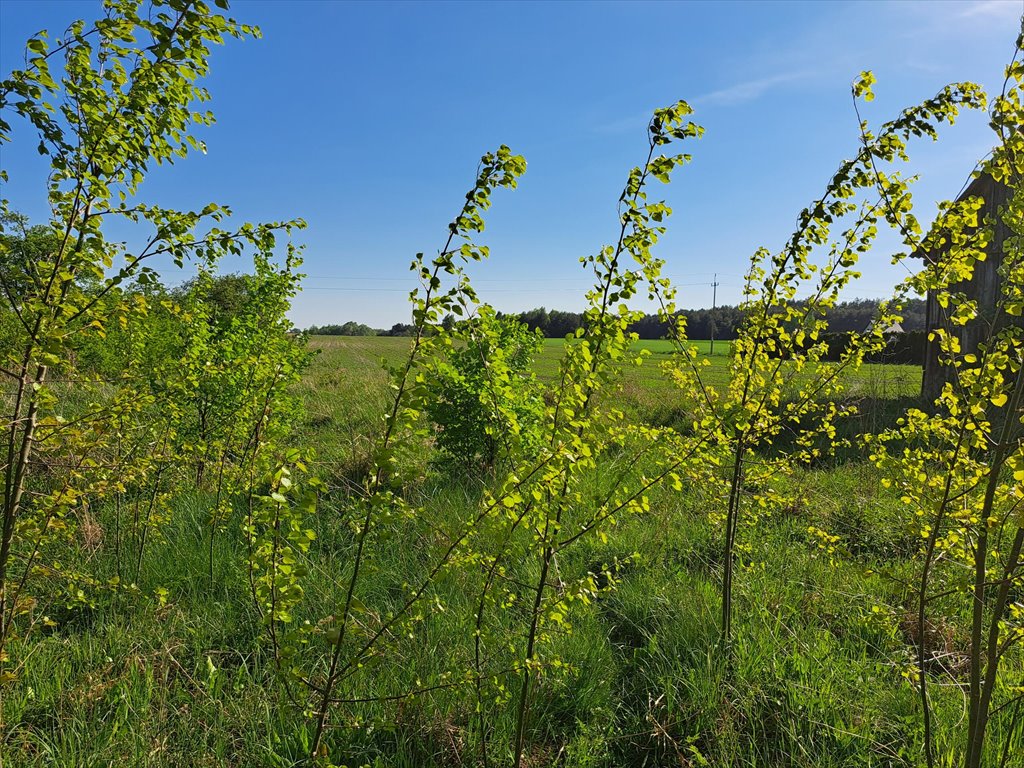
0, 0, 1024, 327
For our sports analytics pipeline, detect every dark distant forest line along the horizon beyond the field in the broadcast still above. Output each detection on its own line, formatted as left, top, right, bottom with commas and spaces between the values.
307, 299, 925, 340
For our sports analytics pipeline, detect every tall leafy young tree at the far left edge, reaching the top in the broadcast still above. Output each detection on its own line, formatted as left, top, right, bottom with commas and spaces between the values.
0, 0, 301, 680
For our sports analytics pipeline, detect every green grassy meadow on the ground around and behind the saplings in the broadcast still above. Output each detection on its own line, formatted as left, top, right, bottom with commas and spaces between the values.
6, 337, 1024, 768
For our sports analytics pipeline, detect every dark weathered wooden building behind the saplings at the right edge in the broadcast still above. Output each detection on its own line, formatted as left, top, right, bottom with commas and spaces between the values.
914, 175, 1022, 400
